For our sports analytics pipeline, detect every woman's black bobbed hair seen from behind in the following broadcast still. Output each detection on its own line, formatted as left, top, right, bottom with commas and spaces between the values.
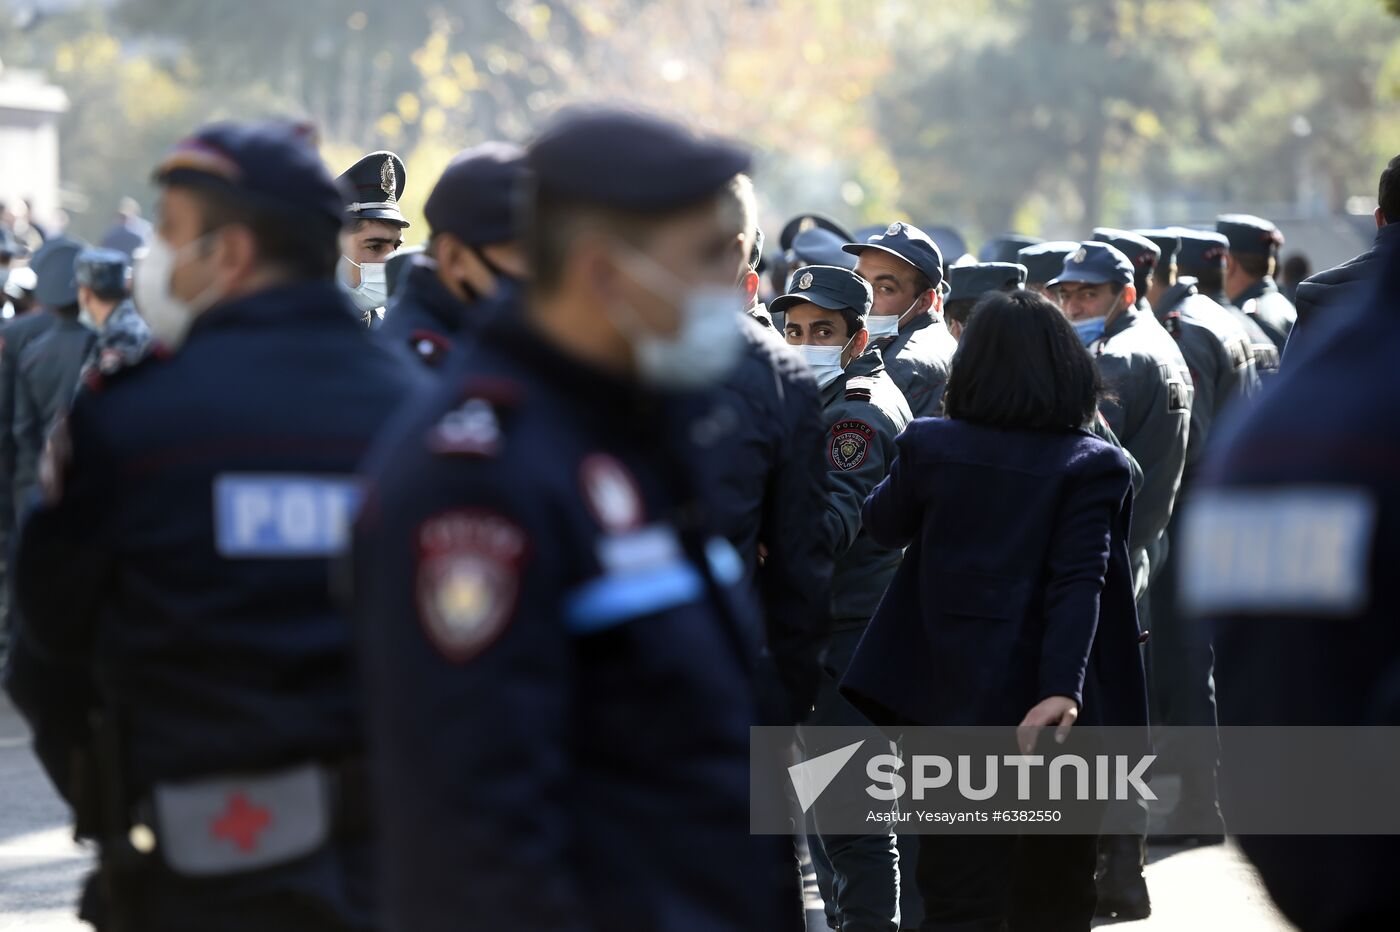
944, 291, 1102, 431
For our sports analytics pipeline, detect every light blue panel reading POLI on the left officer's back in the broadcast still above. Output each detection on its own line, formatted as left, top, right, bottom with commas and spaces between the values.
214, 473, 361, 560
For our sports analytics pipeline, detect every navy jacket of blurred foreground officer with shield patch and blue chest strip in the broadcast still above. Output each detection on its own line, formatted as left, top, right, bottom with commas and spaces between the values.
356, 315, 801, 932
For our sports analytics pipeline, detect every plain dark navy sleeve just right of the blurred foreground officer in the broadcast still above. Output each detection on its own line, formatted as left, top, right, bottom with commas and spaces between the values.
757, 366, 834, 712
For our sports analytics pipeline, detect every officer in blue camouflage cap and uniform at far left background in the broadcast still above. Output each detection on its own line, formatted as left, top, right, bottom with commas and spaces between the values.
76, 249, 151, 375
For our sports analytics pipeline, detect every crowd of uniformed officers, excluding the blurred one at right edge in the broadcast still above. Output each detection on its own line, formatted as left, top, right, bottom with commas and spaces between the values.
0, 103, 1400, 932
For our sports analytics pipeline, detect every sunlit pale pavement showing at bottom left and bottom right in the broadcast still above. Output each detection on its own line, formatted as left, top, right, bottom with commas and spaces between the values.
0, 698, 1292, 932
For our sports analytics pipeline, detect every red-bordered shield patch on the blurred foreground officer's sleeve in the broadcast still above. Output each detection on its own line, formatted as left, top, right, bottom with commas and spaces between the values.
414, 508, 529, 663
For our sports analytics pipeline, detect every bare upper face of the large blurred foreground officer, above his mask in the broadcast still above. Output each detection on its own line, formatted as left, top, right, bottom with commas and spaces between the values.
613, 200, 745, 336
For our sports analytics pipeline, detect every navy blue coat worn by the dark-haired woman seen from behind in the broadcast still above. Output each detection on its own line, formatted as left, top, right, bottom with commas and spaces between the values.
841, 418, 1147, 725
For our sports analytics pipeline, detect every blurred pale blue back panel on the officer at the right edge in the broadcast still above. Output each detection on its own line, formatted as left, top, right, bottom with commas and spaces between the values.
1180, 486, 1376, 617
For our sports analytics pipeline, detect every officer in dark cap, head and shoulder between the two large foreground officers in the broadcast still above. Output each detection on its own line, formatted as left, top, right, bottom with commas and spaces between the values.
379, 143, 525, 369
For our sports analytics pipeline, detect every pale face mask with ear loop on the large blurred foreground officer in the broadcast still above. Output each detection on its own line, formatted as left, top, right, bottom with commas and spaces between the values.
617, 248, 743, 389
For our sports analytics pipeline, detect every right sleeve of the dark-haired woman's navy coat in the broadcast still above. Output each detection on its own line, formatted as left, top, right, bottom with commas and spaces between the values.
1039, 451, 1130, 704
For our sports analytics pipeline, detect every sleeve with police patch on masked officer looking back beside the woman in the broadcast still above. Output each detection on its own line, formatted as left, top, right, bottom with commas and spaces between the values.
822, 403, 889, 560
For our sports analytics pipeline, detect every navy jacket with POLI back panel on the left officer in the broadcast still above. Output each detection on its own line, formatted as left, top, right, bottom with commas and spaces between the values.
8, 283, 416, 928
